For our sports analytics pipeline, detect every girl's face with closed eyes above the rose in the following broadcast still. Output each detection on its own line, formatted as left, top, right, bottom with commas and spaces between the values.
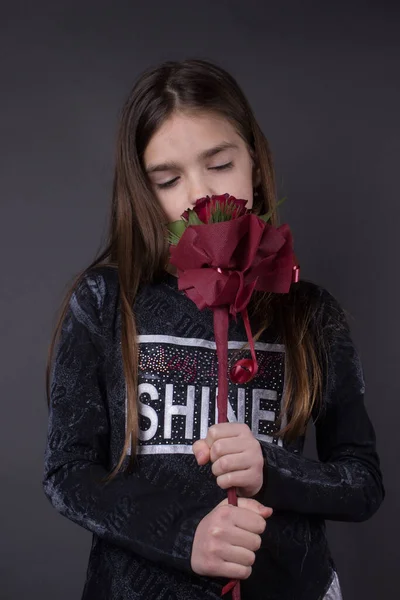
144, 113, 259, 222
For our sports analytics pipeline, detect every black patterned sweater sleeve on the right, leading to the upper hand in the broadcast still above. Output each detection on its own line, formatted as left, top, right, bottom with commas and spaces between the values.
260, 288, 385, 521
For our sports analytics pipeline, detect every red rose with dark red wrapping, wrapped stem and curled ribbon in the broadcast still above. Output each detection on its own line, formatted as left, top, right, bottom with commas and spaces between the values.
170, 199, 298, 599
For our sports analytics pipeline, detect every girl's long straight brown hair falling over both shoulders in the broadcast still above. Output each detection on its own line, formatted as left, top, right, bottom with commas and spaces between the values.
47, 59, 322, 479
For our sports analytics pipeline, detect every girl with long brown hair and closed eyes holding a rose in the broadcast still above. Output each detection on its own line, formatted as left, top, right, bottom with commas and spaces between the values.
43, 60, 384, 600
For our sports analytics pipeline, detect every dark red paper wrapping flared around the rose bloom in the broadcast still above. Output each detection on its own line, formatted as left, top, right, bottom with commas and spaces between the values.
170, 214, 294, 315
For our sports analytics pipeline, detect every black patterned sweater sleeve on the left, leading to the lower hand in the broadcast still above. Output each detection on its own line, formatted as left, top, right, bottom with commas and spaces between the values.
43, 280, 213, 574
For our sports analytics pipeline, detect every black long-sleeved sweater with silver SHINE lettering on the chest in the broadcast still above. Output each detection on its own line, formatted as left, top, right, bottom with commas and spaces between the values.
43, 267, 384, 600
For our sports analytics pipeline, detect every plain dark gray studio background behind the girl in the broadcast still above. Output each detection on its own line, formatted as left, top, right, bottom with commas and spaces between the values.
0, 0, 400, 600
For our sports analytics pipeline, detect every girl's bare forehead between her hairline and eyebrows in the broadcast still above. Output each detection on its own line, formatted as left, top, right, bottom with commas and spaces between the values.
144, 113, 245, 165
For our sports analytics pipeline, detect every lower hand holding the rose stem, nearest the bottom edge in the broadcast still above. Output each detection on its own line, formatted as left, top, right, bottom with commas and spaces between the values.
191, 498, 272, 579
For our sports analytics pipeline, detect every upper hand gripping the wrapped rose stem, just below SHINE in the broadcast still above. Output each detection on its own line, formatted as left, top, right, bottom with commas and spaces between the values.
193, 423, 264, 498
